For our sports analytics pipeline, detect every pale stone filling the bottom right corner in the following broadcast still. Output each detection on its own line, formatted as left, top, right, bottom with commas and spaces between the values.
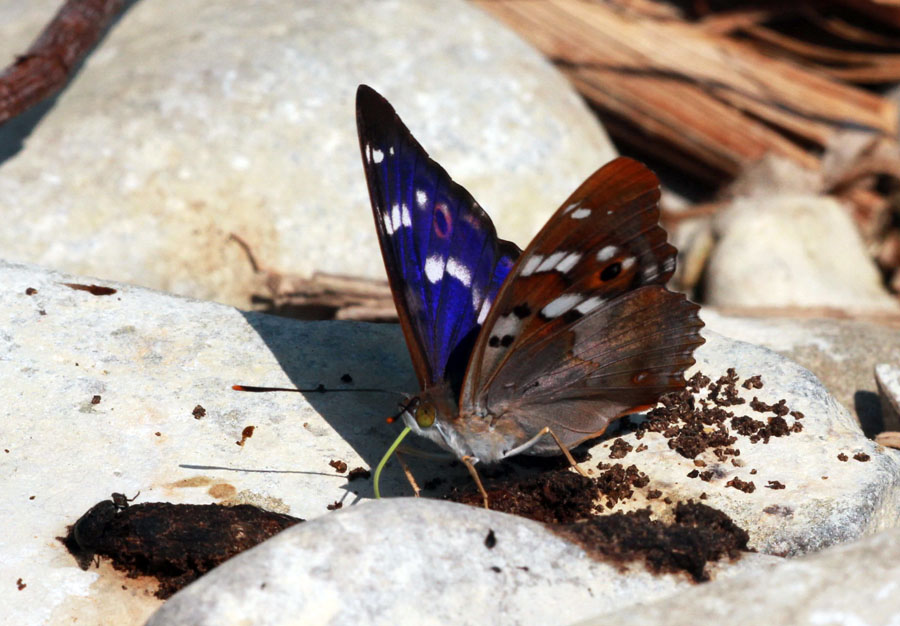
579, 530, 900, 626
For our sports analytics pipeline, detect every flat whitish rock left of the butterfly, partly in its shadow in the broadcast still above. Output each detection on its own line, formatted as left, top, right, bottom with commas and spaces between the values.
0, 262, 416, 625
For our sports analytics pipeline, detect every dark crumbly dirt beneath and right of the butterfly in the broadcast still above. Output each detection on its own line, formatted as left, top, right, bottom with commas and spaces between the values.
444, 369, 816, 581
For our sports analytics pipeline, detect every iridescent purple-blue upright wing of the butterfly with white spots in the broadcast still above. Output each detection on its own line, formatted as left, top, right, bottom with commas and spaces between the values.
356, 85, 521, 390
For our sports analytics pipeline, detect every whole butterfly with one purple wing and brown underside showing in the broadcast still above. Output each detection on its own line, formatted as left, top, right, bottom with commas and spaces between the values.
356, 85, 704, 504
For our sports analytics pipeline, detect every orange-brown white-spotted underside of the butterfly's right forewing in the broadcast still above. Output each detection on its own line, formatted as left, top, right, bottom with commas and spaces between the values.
460, 158, 676, 406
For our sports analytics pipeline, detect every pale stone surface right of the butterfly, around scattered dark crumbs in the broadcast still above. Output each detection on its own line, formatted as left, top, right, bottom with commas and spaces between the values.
591, 330, 900, 556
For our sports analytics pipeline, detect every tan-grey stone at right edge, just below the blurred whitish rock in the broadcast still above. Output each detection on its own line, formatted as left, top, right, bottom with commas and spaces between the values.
700, 307, 900, 437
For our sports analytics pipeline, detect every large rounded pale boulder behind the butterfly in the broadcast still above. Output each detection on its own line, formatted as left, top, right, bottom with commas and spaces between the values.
0, 0, 614, 307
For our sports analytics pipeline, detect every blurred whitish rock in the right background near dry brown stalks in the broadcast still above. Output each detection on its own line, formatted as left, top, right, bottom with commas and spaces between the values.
705, 195, 898, 312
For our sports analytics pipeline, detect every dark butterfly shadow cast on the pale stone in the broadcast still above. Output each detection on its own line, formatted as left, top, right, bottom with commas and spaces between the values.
236, 311, 468, 497
